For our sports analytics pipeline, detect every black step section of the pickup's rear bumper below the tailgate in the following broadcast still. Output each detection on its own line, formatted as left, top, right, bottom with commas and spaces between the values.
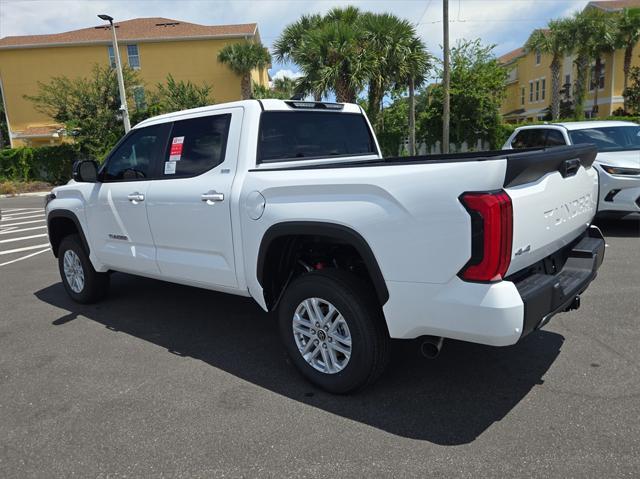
514, 226, 605, 337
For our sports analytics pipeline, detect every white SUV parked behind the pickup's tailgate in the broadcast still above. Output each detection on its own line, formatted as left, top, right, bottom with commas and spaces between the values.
503, 121, 640, 217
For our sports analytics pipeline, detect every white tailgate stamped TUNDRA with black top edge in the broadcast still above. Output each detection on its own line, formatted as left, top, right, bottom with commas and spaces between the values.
504, 145, 598, 275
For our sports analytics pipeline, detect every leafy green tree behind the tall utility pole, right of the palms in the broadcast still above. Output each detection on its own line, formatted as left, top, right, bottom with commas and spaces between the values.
418, 40, 507, 148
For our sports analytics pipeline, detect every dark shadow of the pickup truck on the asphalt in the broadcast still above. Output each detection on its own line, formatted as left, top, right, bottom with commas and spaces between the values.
36, 274, 564, 445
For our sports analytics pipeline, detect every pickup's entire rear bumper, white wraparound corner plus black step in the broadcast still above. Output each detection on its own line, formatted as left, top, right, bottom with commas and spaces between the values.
383, 227, 604, 346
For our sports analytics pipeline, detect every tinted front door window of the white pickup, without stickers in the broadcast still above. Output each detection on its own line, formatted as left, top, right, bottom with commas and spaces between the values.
100, 123, 171, 181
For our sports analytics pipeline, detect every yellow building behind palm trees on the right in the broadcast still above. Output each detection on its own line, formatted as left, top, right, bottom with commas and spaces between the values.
498, 0, 640, 123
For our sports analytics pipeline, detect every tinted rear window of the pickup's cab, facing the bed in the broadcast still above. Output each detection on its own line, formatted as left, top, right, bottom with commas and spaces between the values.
258, 111, 378, 162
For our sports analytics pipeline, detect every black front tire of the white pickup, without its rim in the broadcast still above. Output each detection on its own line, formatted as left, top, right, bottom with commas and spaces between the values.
58, 234, 109, 304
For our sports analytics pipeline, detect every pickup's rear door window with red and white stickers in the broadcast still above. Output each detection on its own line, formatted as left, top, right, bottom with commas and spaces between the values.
163, 113, 231, 178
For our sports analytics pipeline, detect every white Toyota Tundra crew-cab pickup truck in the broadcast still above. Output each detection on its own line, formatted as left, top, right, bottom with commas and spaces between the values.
46, 100, 604, 393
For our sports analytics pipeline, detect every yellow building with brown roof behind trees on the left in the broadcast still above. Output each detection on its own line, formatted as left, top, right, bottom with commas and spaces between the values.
0, 18, 269, 147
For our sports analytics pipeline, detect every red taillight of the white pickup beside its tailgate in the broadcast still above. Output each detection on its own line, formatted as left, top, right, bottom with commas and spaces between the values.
459, 191, 513, 281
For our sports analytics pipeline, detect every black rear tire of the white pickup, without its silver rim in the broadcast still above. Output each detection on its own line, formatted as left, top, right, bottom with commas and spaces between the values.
278, 269, 389, 394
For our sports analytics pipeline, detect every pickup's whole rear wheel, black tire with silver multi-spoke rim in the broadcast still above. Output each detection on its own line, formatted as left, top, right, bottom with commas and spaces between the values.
279, 269, 388, 393
